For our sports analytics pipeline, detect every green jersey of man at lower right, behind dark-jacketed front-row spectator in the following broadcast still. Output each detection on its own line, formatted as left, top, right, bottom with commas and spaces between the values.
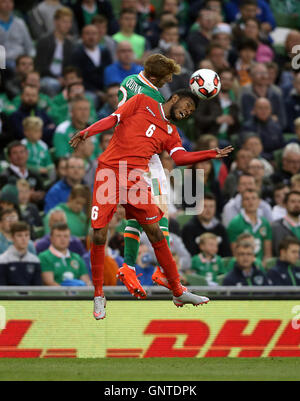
227, 210, 272, 260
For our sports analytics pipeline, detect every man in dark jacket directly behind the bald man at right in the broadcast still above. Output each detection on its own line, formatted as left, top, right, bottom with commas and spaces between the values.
240, 63, 286, 129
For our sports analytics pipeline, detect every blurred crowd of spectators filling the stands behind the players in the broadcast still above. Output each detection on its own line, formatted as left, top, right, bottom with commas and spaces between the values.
0, 0, 300, 286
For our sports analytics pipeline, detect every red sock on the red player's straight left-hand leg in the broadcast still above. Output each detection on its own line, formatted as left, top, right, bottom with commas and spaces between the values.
91, 243, 105, 297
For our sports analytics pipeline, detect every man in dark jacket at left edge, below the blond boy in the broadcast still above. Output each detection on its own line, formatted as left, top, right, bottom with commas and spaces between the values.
0, 141, 45, 203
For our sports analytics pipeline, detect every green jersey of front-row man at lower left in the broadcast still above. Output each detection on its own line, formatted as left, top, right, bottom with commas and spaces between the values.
38, 246, 88, 284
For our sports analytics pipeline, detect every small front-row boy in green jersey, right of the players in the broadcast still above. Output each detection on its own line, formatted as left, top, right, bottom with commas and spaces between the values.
191, 233, 225, 285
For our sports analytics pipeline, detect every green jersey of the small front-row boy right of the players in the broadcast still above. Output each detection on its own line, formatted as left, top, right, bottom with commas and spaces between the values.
191, 253, 225, 282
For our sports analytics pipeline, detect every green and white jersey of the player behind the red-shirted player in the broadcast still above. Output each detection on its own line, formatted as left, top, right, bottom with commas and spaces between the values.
118, 71, 166, 106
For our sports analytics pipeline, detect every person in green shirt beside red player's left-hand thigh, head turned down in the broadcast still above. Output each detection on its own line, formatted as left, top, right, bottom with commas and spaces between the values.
44, 184, 91, 240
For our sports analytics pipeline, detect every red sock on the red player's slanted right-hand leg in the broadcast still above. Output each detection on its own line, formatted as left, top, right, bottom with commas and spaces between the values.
152, 239, 182, 297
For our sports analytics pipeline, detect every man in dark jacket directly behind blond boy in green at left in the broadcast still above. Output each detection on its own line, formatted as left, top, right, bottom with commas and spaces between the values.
10, 85, 55, 146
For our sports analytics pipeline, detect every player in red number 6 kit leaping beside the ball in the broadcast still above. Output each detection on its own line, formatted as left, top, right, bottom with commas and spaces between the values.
70, 90, 233, 320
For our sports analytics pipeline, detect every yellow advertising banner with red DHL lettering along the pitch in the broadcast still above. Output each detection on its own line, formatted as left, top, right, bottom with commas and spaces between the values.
0, 300, 300, 358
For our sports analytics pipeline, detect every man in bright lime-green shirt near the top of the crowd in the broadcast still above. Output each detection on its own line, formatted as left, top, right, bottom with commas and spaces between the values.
113, 8, 146, 62
